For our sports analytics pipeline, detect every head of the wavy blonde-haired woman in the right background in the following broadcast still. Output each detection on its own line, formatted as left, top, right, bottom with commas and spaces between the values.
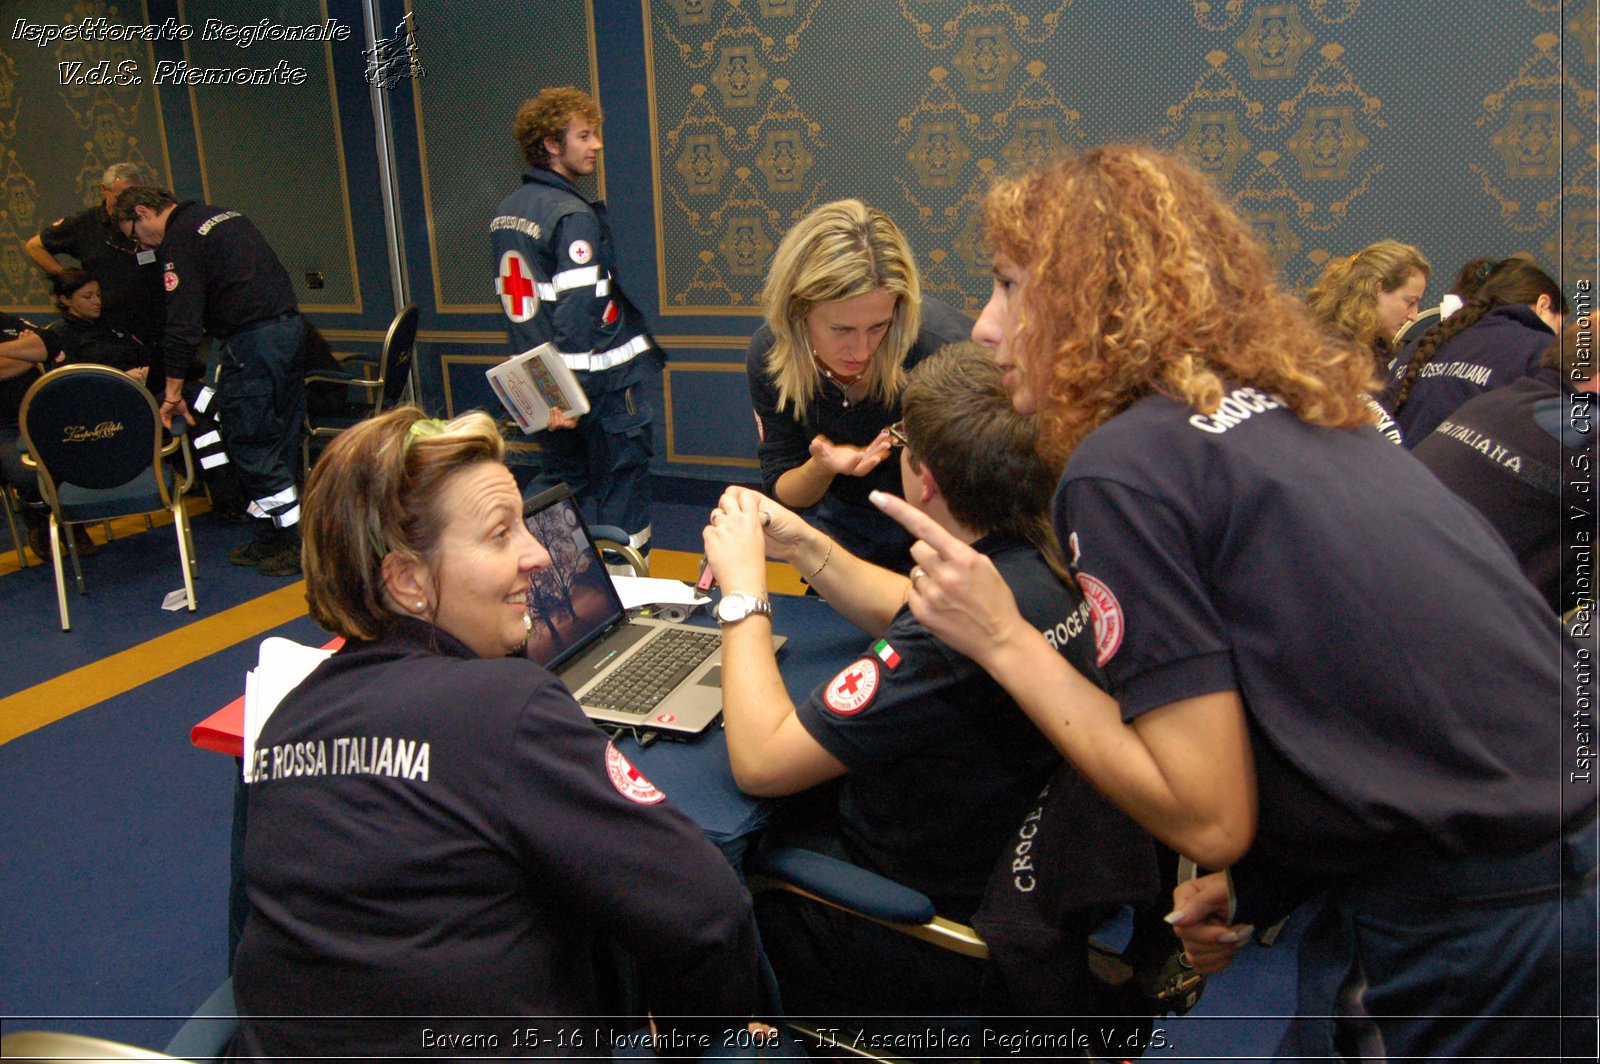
1306, 240, 1434, 376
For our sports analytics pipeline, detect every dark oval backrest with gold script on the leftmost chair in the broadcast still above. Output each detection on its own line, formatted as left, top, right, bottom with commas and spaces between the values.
21, 365, 162, 498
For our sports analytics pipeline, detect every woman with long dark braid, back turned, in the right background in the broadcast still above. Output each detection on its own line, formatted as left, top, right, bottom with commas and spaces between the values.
1381, 258, 1566, 446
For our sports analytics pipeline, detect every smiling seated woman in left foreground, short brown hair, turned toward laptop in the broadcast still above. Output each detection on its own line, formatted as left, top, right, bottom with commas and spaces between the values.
232, 406, 757, 1059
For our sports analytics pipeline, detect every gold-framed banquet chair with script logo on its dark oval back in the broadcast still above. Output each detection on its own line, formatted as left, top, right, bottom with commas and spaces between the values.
19, 363, 195, 632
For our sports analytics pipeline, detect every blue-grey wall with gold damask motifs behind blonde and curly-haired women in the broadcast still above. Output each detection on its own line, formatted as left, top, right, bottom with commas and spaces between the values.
642, 0, 1597, 315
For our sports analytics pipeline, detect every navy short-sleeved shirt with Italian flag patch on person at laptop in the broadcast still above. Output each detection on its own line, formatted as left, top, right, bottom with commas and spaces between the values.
797, 536, 1098, 920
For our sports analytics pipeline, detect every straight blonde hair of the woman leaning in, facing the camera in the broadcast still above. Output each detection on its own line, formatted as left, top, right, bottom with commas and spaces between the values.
762, 200, 922, 419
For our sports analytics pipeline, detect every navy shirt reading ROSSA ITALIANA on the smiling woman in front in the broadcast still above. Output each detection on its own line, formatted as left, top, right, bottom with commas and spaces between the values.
234, 619, 755, 1058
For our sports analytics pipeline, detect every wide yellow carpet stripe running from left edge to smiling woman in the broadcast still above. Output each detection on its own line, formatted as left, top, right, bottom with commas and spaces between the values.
0, 581, 306, 742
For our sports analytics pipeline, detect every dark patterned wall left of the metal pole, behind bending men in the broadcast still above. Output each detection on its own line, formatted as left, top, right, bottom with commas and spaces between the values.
0, 0, 371, 325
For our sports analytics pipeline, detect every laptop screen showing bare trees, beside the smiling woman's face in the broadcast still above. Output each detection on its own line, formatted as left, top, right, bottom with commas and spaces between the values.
522, 485, 624, 670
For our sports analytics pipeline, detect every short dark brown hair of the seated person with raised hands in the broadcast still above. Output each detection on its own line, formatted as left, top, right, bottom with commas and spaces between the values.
901, 341, 1058, 562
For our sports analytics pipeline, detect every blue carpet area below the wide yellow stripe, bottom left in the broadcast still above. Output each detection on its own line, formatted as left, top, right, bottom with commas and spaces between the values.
0, 619, 326, 1046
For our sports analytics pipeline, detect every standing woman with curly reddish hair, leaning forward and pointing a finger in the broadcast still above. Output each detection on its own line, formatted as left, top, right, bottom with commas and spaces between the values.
874, 146, 1595, 1059
